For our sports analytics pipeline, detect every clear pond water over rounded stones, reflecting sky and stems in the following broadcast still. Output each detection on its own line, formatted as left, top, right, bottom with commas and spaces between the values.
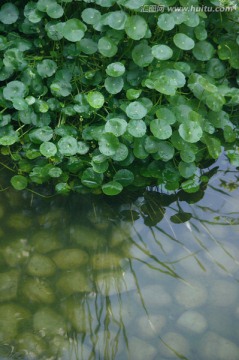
0, 153, 239, 360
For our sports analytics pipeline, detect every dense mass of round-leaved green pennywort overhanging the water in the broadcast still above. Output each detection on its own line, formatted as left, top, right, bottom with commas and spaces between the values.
0, 0, 239, 195
